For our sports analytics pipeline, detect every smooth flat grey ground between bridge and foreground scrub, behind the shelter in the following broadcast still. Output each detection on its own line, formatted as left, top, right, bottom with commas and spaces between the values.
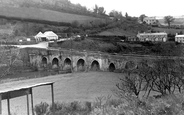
0, 72, 123, 115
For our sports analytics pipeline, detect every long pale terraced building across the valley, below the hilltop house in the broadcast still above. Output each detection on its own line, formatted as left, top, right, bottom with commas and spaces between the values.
137, 32, 167, 42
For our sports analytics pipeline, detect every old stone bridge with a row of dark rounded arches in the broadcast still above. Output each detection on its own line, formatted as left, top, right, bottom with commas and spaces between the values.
23, 48, 181, 71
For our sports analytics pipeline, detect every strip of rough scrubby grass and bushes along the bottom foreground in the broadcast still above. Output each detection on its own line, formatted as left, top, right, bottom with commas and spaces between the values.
34, 95, 184, 115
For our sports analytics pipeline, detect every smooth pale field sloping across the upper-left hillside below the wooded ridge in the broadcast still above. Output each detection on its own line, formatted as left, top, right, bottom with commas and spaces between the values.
0, 5, 101, 23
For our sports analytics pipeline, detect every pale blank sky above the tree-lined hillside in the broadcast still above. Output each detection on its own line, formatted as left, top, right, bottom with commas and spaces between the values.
70, 0, 184, 17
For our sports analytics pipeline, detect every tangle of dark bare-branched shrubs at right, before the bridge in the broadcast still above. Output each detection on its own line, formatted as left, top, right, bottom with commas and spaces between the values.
117, 59, 184, 98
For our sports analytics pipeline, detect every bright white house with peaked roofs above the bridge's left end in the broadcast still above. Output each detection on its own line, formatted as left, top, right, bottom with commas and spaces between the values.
35, 31, 58, 42
